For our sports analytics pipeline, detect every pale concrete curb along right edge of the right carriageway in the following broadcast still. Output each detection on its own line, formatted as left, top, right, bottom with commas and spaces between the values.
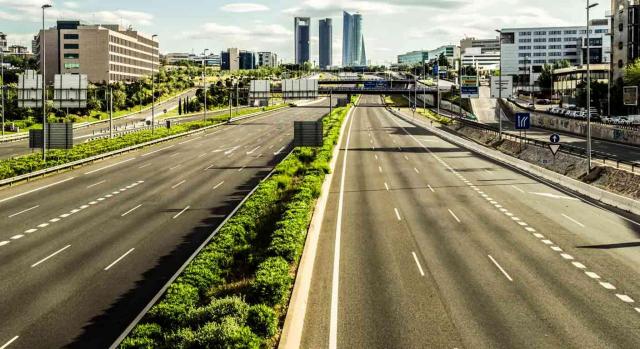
391, 110, 640, 215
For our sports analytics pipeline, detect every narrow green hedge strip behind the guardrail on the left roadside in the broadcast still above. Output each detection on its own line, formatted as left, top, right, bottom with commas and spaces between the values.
0, 105, 283, 180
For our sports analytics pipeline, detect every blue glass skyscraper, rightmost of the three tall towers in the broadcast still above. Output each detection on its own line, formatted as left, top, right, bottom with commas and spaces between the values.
342, 12, 367, 67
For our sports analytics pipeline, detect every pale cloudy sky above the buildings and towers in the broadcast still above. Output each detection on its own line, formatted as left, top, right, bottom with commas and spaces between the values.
0, 0, 610, 64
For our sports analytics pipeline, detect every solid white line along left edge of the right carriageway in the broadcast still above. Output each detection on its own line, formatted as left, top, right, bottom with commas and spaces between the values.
329, 104, 354, 349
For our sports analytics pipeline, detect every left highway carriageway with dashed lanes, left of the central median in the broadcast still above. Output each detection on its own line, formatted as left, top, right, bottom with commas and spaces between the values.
0, 96, 328, 349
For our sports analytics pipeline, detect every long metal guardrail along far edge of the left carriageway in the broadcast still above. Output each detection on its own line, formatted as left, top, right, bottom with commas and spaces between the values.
0, 108, 283, 187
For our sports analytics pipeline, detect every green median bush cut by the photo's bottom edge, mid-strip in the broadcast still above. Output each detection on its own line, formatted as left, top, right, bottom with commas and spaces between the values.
195, 317, 261, 349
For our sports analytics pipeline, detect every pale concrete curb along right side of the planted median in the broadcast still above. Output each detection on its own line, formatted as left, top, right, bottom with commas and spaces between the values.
278, 96, 357, 349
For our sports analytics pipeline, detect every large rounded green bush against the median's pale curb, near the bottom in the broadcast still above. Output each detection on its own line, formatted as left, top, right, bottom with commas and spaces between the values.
252, 257, 293, 306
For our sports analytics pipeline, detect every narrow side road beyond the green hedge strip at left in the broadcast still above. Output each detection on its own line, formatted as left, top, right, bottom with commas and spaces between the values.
0, 89, 198, 160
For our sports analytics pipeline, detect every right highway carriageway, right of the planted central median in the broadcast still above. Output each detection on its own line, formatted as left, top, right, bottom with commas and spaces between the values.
301, 96, 640, 349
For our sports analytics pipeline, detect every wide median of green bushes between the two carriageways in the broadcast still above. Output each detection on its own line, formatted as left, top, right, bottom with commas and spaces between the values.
120, 100, 351, 349
